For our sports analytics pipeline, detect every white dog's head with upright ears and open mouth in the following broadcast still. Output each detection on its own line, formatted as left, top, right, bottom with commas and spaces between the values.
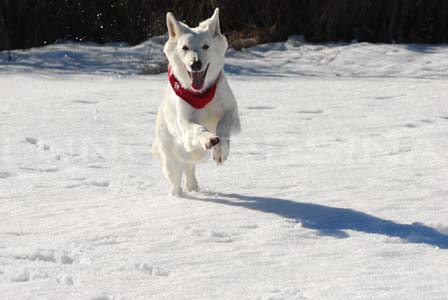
164, 8, 228, 91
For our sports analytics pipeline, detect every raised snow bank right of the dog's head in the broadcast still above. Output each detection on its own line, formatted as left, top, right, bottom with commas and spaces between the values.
228, 37, 448, 79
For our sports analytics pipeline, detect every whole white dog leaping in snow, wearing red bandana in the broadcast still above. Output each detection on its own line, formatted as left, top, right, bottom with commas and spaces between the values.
152, 9, 240, 196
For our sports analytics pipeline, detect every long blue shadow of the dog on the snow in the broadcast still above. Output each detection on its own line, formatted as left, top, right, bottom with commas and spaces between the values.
188, 193, 448, 249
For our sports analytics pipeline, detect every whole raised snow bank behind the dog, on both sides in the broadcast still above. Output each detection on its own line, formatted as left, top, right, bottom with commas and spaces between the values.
0, 36, 448, 79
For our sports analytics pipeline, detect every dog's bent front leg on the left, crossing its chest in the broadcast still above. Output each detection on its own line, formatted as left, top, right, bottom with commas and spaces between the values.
177, 108, 220, 151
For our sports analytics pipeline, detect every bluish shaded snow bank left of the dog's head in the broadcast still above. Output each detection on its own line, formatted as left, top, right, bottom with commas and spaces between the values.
0, 36, 167, 75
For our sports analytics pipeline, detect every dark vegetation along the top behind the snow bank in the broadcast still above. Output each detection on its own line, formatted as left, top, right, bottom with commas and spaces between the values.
0, 0, 448, 50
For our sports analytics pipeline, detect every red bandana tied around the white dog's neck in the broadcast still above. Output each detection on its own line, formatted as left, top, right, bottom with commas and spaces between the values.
168, 66, 221, 109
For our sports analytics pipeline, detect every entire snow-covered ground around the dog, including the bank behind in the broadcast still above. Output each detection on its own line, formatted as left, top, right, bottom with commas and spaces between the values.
0, 39, 448, 300
